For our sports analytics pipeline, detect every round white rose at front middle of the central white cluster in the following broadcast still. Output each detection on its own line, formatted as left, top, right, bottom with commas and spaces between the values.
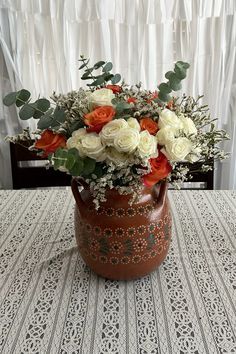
114, 128, 140, 153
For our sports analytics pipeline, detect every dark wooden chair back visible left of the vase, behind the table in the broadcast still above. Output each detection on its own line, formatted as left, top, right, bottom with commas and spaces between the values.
10, 143, 71, 189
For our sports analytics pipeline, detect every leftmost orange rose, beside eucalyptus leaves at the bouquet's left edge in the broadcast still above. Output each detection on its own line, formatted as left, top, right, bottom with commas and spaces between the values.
34, 129, 66, 157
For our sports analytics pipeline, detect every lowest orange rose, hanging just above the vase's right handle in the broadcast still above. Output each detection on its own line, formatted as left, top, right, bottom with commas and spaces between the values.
143, 151, 172, 187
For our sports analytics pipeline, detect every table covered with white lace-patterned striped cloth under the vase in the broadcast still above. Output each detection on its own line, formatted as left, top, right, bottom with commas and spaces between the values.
0, 189, 236, 354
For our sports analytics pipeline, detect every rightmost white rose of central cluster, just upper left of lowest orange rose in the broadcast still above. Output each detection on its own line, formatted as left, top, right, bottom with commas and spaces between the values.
137, 130, 158, 158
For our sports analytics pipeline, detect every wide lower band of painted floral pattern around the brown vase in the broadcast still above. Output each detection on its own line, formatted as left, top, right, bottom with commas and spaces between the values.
78, 210, 171, 265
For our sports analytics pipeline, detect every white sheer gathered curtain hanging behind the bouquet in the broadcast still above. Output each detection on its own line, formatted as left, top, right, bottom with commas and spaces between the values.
0, 0, 236, 189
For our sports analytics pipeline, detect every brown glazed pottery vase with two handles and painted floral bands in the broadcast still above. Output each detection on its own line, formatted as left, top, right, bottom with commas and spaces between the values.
71, 179, 171, 280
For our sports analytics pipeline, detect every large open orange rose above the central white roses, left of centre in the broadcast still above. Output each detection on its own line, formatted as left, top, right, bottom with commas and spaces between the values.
84, 106, 116, 133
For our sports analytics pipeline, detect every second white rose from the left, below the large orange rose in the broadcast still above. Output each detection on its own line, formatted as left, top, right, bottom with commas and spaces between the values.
78, 133, 106, 161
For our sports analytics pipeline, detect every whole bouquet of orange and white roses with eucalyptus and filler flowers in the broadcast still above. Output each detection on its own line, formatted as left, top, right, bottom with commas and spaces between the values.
3, 56, 228, 208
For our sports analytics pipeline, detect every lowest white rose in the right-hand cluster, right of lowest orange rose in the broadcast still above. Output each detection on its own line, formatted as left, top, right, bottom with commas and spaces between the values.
165, 138, 192, 161
